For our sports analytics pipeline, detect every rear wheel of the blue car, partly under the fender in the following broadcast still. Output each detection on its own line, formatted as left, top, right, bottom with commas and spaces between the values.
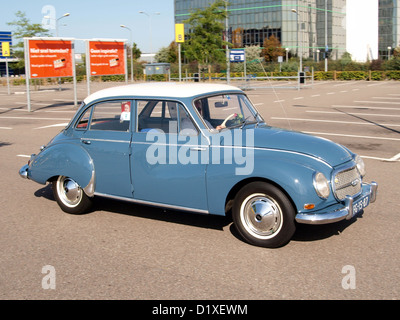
52, 176, 92, 214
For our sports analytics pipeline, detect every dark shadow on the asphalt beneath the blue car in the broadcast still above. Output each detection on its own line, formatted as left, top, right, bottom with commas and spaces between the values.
34, 184, 363, 242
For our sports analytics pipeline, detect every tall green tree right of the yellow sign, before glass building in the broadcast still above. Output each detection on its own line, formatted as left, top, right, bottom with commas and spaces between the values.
183, 0, 229, 72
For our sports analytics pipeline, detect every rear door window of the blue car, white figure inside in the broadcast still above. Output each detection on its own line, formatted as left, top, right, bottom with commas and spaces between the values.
89, 101, 131, 131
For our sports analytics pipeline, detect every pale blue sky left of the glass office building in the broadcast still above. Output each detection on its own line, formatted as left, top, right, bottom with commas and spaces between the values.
0, 0, 175, 53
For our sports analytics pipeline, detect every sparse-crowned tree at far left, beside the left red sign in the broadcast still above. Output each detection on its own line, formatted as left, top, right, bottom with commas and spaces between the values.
7, 11, 50, 69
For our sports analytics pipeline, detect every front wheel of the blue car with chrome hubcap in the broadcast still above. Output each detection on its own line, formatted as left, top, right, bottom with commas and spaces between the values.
232, 182, 296, 248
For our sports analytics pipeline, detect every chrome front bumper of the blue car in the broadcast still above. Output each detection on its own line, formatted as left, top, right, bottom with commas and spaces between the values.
296, 182, 378, 224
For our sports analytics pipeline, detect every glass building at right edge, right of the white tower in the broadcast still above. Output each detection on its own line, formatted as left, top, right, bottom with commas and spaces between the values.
378, 0, 400, 59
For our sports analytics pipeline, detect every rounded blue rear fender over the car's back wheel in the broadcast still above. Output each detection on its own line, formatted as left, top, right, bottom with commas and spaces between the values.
28, 142, 95, 196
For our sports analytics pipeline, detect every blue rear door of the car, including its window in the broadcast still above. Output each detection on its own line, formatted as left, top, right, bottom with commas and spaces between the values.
76, 100, 132, 198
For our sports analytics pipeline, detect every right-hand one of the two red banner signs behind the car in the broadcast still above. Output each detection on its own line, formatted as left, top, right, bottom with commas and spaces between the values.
89, 41, 125, 76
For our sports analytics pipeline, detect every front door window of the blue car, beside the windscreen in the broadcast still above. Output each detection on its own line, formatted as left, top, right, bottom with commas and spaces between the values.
137, 100, 198, 135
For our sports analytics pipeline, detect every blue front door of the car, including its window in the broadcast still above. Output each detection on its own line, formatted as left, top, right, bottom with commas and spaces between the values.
131, 100, 209, 212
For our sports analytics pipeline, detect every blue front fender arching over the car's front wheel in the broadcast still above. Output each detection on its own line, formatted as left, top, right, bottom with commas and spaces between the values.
207, 150, 332, 215
